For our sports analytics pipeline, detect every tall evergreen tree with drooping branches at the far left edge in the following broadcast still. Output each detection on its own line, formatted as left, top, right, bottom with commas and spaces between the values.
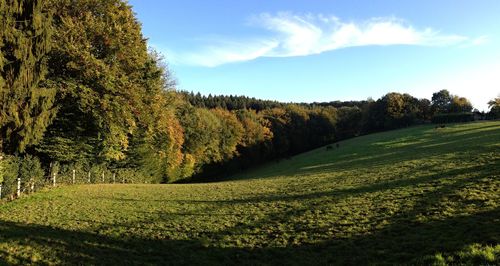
0, 0, 56, 153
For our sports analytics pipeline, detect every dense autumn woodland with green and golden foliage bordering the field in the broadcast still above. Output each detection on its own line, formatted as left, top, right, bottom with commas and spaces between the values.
0, 0, 500, 193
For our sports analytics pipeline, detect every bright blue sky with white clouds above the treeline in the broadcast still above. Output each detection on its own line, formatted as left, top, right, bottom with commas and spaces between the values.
128, 0, 500, 111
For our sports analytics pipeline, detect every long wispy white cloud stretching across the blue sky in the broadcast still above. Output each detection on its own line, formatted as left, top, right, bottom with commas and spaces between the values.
175, 13, 480, 67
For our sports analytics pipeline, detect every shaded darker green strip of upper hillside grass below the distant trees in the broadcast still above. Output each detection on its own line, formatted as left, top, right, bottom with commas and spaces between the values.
228, 123, 500, 181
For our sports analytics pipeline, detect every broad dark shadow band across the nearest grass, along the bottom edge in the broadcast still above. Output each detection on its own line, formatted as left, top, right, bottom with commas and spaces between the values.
0, 209, 500, 265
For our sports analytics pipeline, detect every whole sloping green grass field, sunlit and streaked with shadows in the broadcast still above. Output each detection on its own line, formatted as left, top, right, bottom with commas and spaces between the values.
0, 122, 500, 265
